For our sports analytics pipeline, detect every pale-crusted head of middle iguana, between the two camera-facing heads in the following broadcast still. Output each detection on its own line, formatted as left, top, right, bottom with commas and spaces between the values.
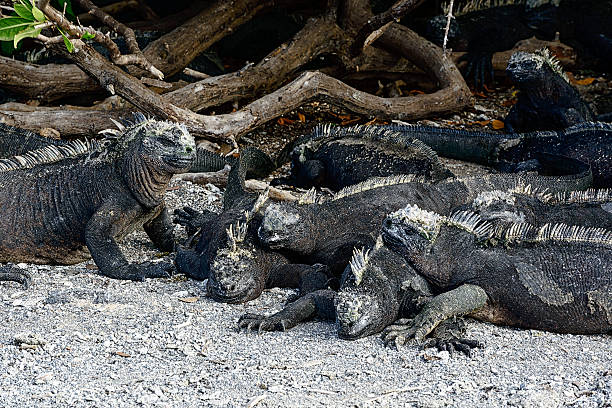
257, 203, 316, 254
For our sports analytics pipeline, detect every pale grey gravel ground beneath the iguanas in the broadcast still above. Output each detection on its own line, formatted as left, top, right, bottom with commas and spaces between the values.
0, 181, 612, 407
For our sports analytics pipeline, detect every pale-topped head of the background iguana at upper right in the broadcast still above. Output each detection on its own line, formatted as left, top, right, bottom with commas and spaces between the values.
506, 48, 569, 87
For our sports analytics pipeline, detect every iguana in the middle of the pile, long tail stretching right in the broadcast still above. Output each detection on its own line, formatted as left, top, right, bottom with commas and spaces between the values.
258, 168, 590, 270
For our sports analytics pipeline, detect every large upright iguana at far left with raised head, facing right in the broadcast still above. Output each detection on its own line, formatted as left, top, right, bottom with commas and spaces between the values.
0, 114, 195, 280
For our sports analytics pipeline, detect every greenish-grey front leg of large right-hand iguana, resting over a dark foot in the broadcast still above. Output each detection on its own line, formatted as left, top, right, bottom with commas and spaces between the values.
383, 284, 489, 346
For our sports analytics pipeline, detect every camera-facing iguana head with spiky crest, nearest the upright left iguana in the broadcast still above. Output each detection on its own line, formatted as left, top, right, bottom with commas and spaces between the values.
208, 190, 268, 303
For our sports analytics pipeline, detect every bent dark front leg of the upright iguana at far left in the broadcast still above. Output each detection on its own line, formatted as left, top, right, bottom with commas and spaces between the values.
85, 199, 172, 281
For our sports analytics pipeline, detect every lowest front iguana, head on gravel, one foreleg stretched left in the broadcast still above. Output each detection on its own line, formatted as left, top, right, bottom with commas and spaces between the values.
238, 236, 482, 355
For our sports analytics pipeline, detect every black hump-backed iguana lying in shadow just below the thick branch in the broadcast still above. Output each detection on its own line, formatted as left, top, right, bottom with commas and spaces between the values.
282, 125, 453, 190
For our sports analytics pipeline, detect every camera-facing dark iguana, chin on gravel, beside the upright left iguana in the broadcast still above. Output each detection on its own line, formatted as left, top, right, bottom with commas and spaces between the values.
175, 148, 329, 303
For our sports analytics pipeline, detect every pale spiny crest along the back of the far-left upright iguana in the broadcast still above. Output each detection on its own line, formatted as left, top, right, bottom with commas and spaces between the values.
0, 140, 99, 172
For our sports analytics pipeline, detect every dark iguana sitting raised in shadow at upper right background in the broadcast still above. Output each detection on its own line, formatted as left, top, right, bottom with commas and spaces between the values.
504, 48, 595, 133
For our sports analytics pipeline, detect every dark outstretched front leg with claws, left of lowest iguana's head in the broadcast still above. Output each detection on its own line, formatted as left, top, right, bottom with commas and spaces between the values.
238, 289, 336, 332
